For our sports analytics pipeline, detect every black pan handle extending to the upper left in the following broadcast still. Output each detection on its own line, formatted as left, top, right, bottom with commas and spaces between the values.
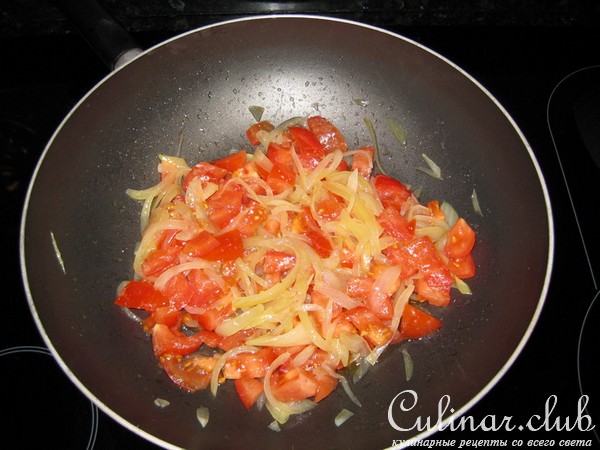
57, 0, 143, 70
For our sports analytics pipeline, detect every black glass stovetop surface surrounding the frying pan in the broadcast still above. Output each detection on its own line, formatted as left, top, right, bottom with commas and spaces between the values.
0, 1, 600, 449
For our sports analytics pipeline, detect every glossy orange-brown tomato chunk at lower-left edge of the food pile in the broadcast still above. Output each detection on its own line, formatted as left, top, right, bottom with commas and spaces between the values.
160, 356, 214, 392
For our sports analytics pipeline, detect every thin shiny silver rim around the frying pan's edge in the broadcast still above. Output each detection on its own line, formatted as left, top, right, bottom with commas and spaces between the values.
19, 14, 555, 449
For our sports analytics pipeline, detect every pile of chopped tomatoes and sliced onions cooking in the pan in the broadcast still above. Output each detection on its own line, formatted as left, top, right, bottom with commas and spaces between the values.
116, 116, 475, 423
